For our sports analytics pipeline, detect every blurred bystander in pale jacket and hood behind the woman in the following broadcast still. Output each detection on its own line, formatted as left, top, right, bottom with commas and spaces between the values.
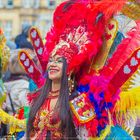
4, 49, 34, 114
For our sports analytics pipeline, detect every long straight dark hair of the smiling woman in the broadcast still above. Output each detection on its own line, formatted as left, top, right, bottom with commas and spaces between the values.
27, 58, 76, 140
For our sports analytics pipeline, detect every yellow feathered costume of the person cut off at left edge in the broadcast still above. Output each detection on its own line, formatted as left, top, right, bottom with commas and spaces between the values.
0, 29, 26, 139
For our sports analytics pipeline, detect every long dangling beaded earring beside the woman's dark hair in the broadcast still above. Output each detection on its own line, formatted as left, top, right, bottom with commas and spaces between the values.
68, 74, 75, 95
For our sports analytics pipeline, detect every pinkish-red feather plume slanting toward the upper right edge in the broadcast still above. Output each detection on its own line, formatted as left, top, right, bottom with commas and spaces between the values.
101, 22, 140, 77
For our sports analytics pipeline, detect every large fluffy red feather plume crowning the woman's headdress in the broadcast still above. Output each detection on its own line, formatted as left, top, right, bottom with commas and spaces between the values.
46, 0, 129, 73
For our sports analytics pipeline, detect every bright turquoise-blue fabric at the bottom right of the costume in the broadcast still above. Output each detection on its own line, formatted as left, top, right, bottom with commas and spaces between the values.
105, 125, 133, 140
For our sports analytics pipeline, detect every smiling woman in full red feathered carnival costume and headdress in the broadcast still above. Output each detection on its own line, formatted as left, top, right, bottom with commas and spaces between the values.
19, 0, 140, 140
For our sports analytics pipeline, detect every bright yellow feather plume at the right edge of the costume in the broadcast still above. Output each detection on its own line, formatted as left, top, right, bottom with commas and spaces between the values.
114, 87, 140, 125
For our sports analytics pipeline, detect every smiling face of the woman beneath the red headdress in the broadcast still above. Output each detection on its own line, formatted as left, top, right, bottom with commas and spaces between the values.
47, 55, 63, 81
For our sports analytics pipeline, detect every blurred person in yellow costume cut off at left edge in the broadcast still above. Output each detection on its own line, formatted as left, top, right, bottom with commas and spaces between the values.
0, 29, 28, 139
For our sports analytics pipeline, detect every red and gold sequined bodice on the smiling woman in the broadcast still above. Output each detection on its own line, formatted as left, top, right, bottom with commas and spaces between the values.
33, 94, 62, 140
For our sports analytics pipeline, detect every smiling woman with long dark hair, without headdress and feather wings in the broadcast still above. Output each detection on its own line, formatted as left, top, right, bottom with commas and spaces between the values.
27, 55, 76, 140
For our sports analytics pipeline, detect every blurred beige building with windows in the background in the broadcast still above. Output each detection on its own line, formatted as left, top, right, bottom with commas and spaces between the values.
0, 0, 63, 40
